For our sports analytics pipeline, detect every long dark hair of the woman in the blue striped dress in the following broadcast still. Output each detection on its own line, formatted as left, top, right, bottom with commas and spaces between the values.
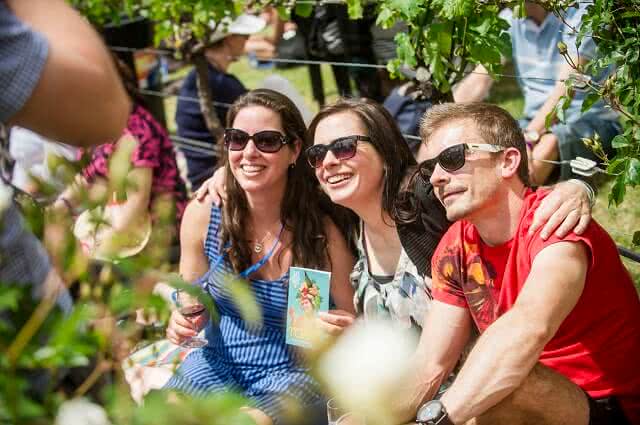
221, 89, 344, 272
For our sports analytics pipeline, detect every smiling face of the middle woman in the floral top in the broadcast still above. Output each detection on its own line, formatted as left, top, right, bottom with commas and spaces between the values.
313, 112, 384, 212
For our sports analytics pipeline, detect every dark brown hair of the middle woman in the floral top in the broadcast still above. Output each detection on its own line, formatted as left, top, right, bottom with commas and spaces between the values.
307, 99, 416, 225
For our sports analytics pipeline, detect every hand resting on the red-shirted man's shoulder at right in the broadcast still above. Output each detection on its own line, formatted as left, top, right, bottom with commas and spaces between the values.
529, 181, 591, 240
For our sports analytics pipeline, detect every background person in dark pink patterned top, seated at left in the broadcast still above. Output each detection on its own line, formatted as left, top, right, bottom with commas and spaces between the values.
53, 59, 187, 258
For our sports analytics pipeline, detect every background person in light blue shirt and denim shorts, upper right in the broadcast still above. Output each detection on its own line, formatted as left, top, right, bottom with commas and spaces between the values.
454, 2, 622, 185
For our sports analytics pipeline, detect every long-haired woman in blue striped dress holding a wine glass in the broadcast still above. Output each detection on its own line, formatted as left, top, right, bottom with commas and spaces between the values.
167, 89, 354, 424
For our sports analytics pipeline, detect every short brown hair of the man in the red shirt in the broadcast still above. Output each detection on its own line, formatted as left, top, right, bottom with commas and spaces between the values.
420, 102, 531, 186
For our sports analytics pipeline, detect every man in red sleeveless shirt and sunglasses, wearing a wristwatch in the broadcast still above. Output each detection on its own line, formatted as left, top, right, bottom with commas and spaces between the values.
393, 103, 640, 425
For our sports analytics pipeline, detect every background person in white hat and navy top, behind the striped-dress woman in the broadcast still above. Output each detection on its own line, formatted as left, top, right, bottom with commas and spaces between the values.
176, 15, 265, 190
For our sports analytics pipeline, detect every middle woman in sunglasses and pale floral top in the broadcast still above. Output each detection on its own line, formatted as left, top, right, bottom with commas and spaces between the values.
307, 99, 440, 332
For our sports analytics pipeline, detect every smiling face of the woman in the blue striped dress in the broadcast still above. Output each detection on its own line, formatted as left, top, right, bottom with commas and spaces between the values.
228, 106, 300, 196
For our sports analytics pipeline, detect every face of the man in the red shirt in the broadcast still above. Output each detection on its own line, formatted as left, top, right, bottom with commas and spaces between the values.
424, 120, 502, 221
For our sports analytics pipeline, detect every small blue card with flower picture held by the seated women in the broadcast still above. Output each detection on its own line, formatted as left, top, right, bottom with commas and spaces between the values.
287, 267, 331, 348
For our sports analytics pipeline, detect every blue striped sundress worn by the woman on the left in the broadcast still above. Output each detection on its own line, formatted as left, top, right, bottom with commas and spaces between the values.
166, 206, 322, 424
